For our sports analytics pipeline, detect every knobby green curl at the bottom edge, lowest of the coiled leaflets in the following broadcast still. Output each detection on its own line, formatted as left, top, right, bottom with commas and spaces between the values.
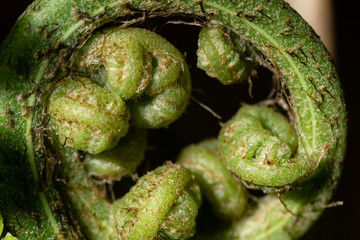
114, 164, 201, 240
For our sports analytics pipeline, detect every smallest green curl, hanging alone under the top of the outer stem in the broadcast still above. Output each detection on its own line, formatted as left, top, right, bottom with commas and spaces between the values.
196, 25, 260, 85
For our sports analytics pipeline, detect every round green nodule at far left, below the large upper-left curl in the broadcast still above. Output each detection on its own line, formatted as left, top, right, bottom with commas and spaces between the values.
47, 77, 129, 154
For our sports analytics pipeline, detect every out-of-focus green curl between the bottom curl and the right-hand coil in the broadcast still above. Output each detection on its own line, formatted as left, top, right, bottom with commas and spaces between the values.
177, 139, 247, 220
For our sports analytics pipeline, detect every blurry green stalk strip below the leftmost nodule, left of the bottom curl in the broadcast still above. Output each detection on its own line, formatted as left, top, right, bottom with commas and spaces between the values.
60, 148, 117, 239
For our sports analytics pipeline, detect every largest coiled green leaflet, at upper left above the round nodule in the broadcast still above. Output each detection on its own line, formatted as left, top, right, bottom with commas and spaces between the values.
74, 28, 191, 128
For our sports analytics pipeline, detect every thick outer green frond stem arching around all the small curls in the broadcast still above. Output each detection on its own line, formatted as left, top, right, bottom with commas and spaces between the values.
0, 0, 346, 239
